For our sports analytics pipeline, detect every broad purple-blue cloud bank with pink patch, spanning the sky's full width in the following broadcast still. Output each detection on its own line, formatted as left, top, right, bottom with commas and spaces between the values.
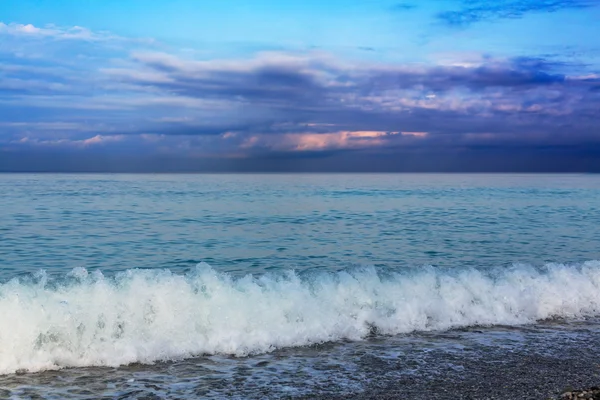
0, 21, 600, 170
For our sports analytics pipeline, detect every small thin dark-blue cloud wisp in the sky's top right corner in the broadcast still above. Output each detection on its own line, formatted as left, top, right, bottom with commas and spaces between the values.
437, 0, 600, 27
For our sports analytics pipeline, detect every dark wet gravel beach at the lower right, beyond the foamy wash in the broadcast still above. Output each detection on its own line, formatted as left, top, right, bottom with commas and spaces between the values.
306, 327, 600, 400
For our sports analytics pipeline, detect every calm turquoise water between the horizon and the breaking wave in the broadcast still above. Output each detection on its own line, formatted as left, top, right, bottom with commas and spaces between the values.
0, 174, 600, 280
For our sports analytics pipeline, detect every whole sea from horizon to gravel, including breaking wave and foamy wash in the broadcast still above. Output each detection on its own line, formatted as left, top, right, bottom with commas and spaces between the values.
0, 174, 600, 399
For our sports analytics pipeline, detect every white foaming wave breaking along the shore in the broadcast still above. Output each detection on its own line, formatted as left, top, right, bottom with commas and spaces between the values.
0, 261, 600, 374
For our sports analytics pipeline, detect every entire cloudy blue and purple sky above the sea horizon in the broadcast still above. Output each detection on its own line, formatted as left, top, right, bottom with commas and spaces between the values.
0, 0, 600, 172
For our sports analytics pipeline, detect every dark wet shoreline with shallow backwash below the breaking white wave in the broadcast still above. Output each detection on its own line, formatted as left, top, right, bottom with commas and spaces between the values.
0, 321, 600, 400
